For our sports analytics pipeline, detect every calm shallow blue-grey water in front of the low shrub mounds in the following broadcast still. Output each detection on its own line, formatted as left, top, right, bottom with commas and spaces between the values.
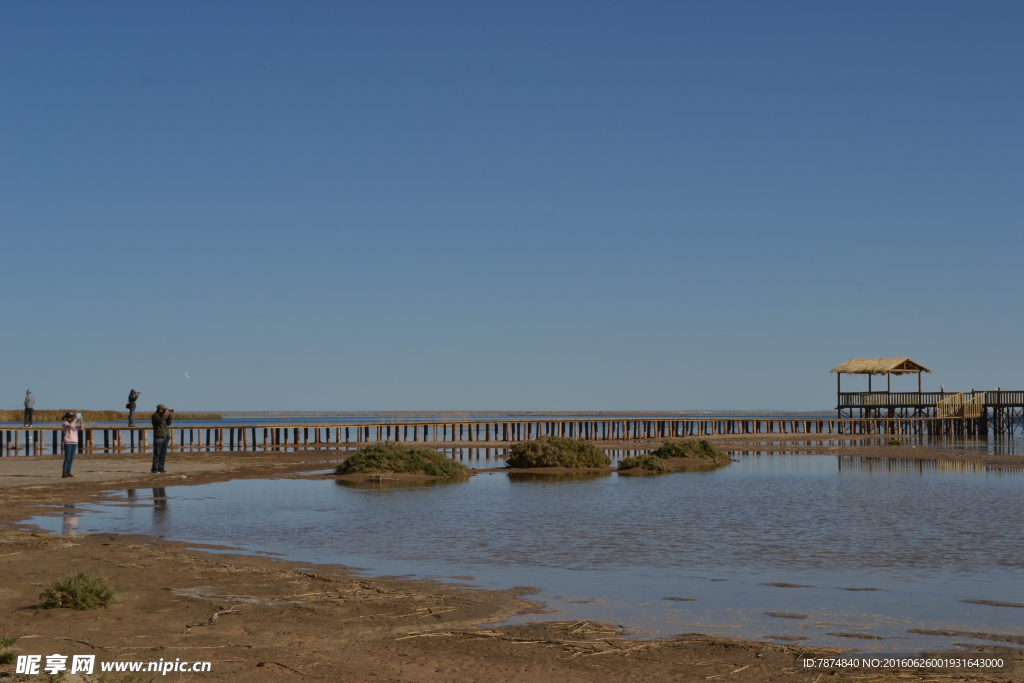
30, 455, 1024, 652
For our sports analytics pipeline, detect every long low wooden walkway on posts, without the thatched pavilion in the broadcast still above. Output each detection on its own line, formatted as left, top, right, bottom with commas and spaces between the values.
0, 416, 987, 456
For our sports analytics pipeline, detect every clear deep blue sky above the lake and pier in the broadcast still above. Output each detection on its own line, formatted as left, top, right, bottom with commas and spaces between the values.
0, 1, 1024, 411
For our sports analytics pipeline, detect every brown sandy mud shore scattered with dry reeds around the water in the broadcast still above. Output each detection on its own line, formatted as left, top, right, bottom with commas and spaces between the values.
0, 437, 1024, 683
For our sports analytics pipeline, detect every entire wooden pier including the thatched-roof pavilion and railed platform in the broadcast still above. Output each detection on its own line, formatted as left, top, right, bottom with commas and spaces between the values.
6, 357, 1024, 456
